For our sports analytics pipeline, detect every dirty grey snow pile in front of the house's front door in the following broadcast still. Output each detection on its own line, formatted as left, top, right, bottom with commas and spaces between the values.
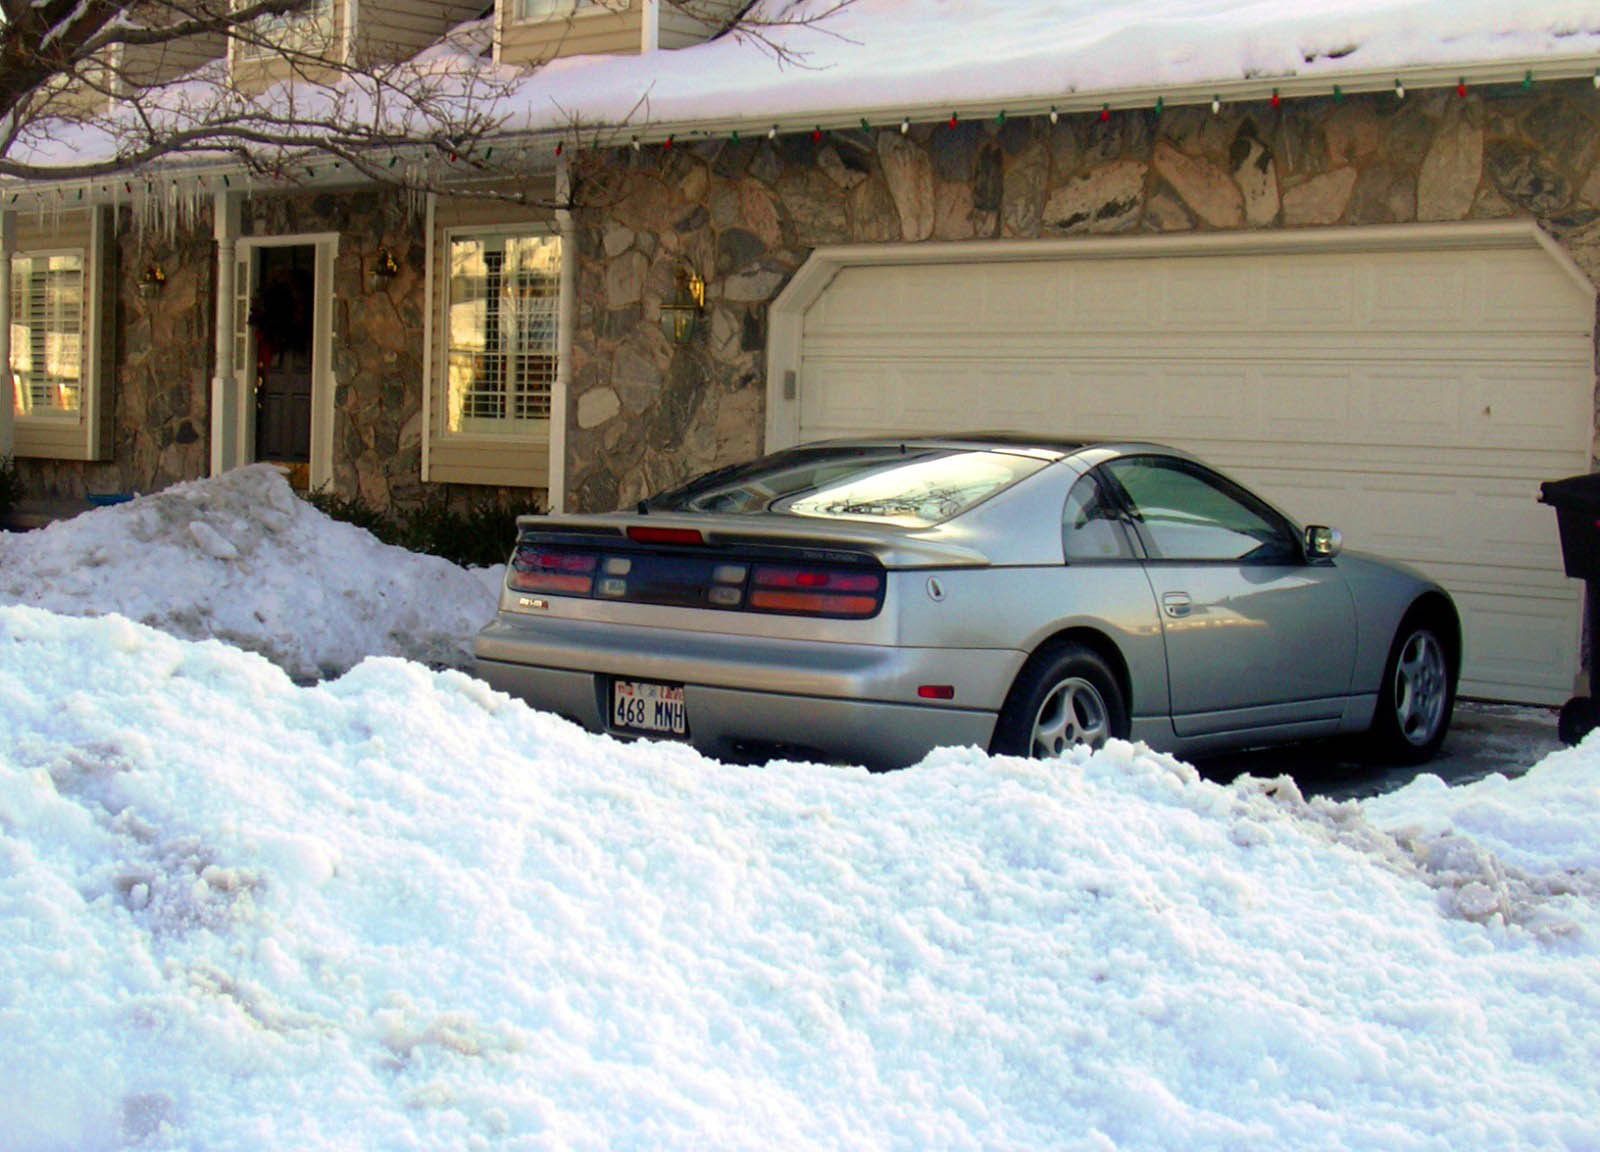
0, 464, 510, 678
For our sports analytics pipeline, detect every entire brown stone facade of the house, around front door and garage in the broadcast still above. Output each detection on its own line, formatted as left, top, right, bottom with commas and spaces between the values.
19, 82, 1600, 510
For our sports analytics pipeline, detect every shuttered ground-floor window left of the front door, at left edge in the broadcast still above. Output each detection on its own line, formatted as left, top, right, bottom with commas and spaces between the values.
11, 253, 83, 416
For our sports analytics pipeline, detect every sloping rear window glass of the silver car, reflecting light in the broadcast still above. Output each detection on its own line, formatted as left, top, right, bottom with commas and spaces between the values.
643, 445, 1046, 528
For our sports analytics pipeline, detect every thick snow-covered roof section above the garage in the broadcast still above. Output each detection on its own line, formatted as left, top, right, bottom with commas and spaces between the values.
496, 0, 1600, 144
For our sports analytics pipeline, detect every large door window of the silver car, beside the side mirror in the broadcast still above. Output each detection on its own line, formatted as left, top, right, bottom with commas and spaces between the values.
1104, 456, 1299, 563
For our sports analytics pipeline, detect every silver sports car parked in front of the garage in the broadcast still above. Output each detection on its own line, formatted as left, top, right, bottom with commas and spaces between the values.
477, 435, 1461, 766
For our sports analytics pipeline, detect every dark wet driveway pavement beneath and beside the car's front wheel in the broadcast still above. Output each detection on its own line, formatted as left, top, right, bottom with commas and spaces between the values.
1195, 701, 1562, 800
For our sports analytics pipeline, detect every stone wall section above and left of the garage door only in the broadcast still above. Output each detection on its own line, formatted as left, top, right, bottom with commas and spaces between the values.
568, 83, 1600, 510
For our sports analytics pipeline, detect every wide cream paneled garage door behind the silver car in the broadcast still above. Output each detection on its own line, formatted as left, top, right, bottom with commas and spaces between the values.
773, 226, 1595, 702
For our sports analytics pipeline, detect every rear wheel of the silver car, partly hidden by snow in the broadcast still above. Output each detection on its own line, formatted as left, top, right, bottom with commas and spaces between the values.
990, 643, 1128, 760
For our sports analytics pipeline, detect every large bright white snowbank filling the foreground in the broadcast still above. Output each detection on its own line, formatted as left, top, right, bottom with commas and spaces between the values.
0, 608, 1600, 1152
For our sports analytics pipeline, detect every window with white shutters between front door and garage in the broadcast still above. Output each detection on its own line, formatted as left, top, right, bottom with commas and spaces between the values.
445, 234, 562, 435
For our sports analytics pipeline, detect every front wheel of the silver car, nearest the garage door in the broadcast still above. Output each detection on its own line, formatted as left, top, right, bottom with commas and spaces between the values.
1368, 613, 1456, 765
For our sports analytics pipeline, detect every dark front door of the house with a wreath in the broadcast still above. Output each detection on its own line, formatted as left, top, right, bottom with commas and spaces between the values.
250, 245, 317, 488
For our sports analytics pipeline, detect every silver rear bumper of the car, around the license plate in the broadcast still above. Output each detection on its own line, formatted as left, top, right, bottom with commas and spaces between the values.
477, 618, 1022, 766
